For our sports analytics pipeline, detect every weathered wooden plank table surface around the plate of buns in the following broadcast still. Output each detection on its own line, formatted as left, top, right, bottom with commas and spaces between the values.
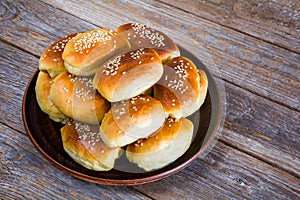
0, 0, 300, 199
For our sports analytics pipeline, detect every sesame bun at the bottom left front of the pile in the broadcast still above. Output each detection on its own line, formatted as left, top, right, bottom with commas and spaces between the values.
61, 121, 122, 171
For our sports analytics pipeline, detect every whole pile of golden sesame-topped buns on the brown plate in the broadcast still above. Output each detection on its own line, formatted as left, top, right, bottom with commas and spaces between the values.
35, 23, 208, 171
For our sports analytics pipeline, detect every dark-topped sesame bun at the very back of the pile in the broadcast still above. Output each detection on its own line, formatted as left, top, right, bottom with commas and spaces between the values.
117, 23, 180, 62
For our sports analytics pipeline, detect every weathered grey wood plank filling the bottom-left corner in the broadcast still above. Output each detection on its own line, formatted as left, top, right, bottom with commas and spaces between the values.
0, 123, 149, 199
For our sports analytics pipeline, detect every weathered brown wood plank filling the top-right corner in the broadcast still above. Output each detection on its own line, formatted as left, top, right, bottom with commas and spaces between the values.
162, 0, 300, 53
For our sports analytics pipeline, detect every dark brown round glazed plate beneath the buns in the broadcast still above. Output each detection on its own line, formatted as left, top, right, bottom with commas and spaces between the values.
22, 47, 222, 185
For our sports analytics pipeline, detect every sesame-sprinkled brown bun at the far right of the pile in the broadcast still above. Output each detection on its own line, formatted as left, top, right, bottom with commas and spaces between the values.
154, 56, 207, 119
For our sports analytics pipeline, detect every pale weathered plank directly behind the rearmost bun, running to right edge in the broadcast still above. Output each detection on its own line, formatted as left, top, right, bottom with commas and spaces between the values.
38, 0, 300, 111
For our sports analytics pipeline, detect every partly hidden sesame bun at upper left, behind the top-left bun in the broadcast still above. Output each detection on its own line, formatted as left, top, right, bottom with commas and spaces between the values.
39, 33, 76, 78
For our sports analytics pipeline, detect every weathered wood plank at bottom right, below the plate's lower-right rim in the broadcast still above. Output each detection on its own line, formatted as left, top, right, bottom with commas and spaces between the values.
134, 143, 300, 199
